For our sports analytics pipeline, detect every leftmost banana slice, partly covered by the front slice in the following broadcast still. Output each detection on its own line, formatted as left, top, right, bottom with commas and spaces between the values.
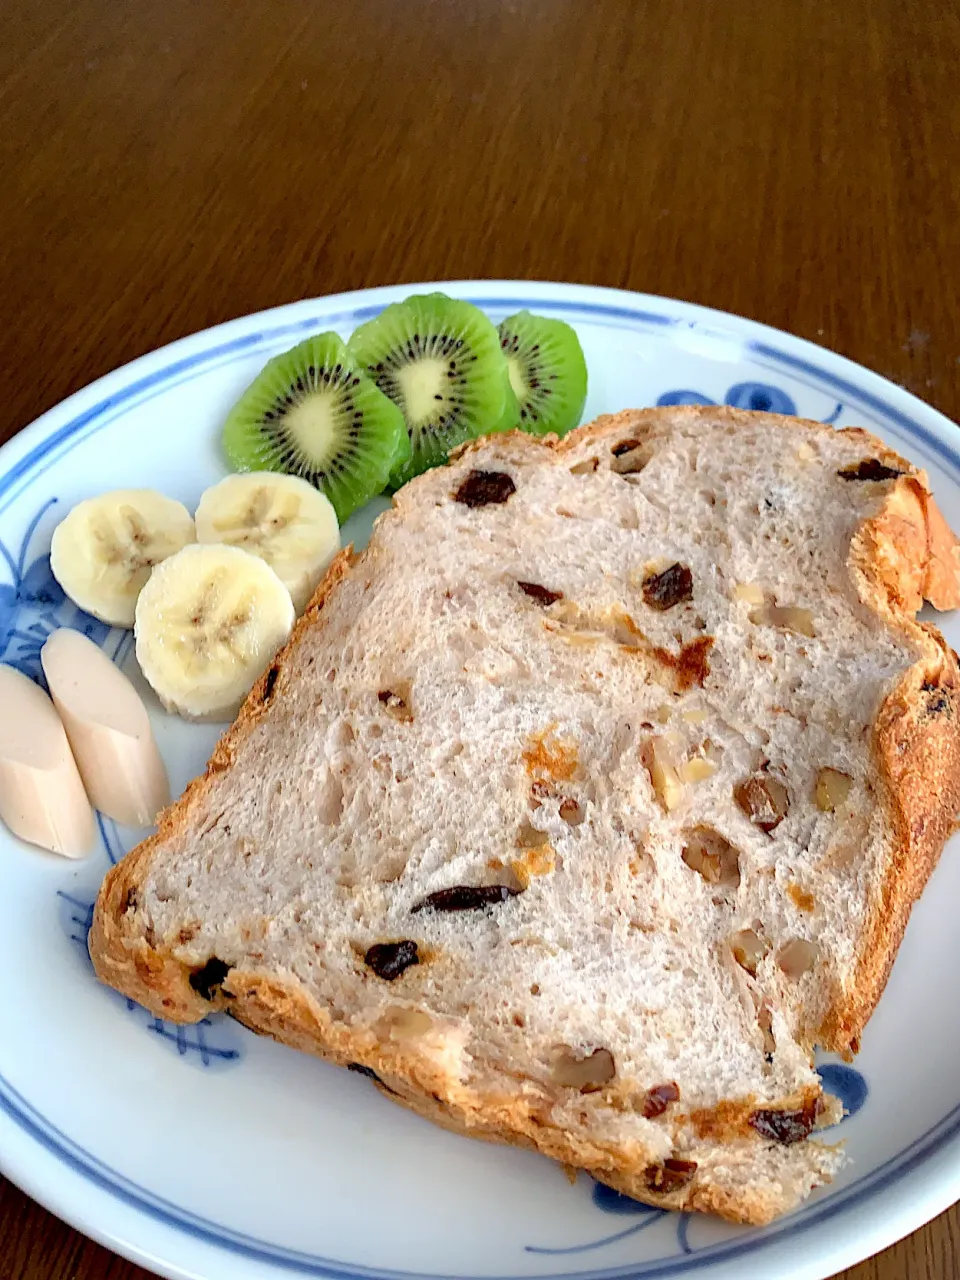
50, 489, 196, 627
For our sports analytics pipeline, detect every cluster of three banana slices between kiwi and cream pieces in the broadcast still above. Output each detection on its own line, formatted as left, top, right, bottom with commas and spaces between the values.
51, 471, 343, 721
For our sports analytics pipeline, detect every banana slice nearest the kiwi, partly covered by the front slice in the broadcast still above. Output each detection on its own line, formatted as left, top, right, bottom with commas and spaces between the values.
196, 471, 340, 613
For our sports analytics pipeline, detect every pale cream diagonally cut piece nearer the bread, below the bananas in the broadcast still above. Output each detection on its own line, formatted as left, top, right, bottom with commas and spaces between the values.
40, 627, 170, 827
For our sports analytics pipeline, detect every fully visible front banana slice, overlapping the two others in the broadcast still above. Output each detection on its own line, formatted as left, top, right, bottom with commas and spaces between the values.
134, 544, 296, 719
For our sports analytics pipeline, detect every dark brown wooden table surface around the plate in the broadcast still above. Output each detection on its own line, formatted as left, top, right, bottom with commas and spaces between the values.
0, 0, 960, 1280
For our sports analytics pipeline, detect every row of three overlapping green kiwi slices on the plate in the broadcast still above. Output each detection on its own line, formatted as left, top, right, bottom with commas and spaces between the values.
223, 293, 586, 506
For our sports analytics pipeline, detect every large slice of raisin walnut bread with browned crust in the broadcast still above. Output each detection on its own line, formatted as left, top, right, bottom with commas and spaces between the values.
92, 408, 960, 1222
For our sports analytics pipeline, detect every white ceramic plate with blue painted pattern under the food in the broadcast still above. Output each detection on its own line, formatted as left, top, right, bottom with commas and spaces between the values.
0, 282, 960, 1280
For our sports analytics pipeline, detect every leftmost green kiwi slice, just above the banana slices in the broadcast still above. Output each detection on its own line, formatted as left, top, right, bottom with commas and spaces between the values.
223, 333, 410, 524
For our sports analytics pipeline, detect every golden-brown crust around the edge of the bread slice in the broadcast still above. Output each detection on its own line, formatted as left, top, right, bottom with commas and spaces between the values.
90, 407, 960, 1224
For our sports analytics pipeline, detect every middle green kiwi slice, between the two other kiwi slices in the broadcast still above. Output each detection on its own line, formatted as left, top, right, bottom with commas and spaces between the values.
349, 293, 520, 489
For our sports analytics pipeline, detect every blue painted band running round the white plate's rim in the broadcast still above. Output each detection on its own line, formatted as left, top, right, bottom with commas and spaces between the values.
0, 297, 960, 1280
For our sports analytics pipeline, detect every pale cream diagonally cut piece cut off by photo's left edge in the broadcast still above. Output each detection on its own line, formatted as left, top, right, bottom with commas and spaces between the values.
0, 666, 95, 858
